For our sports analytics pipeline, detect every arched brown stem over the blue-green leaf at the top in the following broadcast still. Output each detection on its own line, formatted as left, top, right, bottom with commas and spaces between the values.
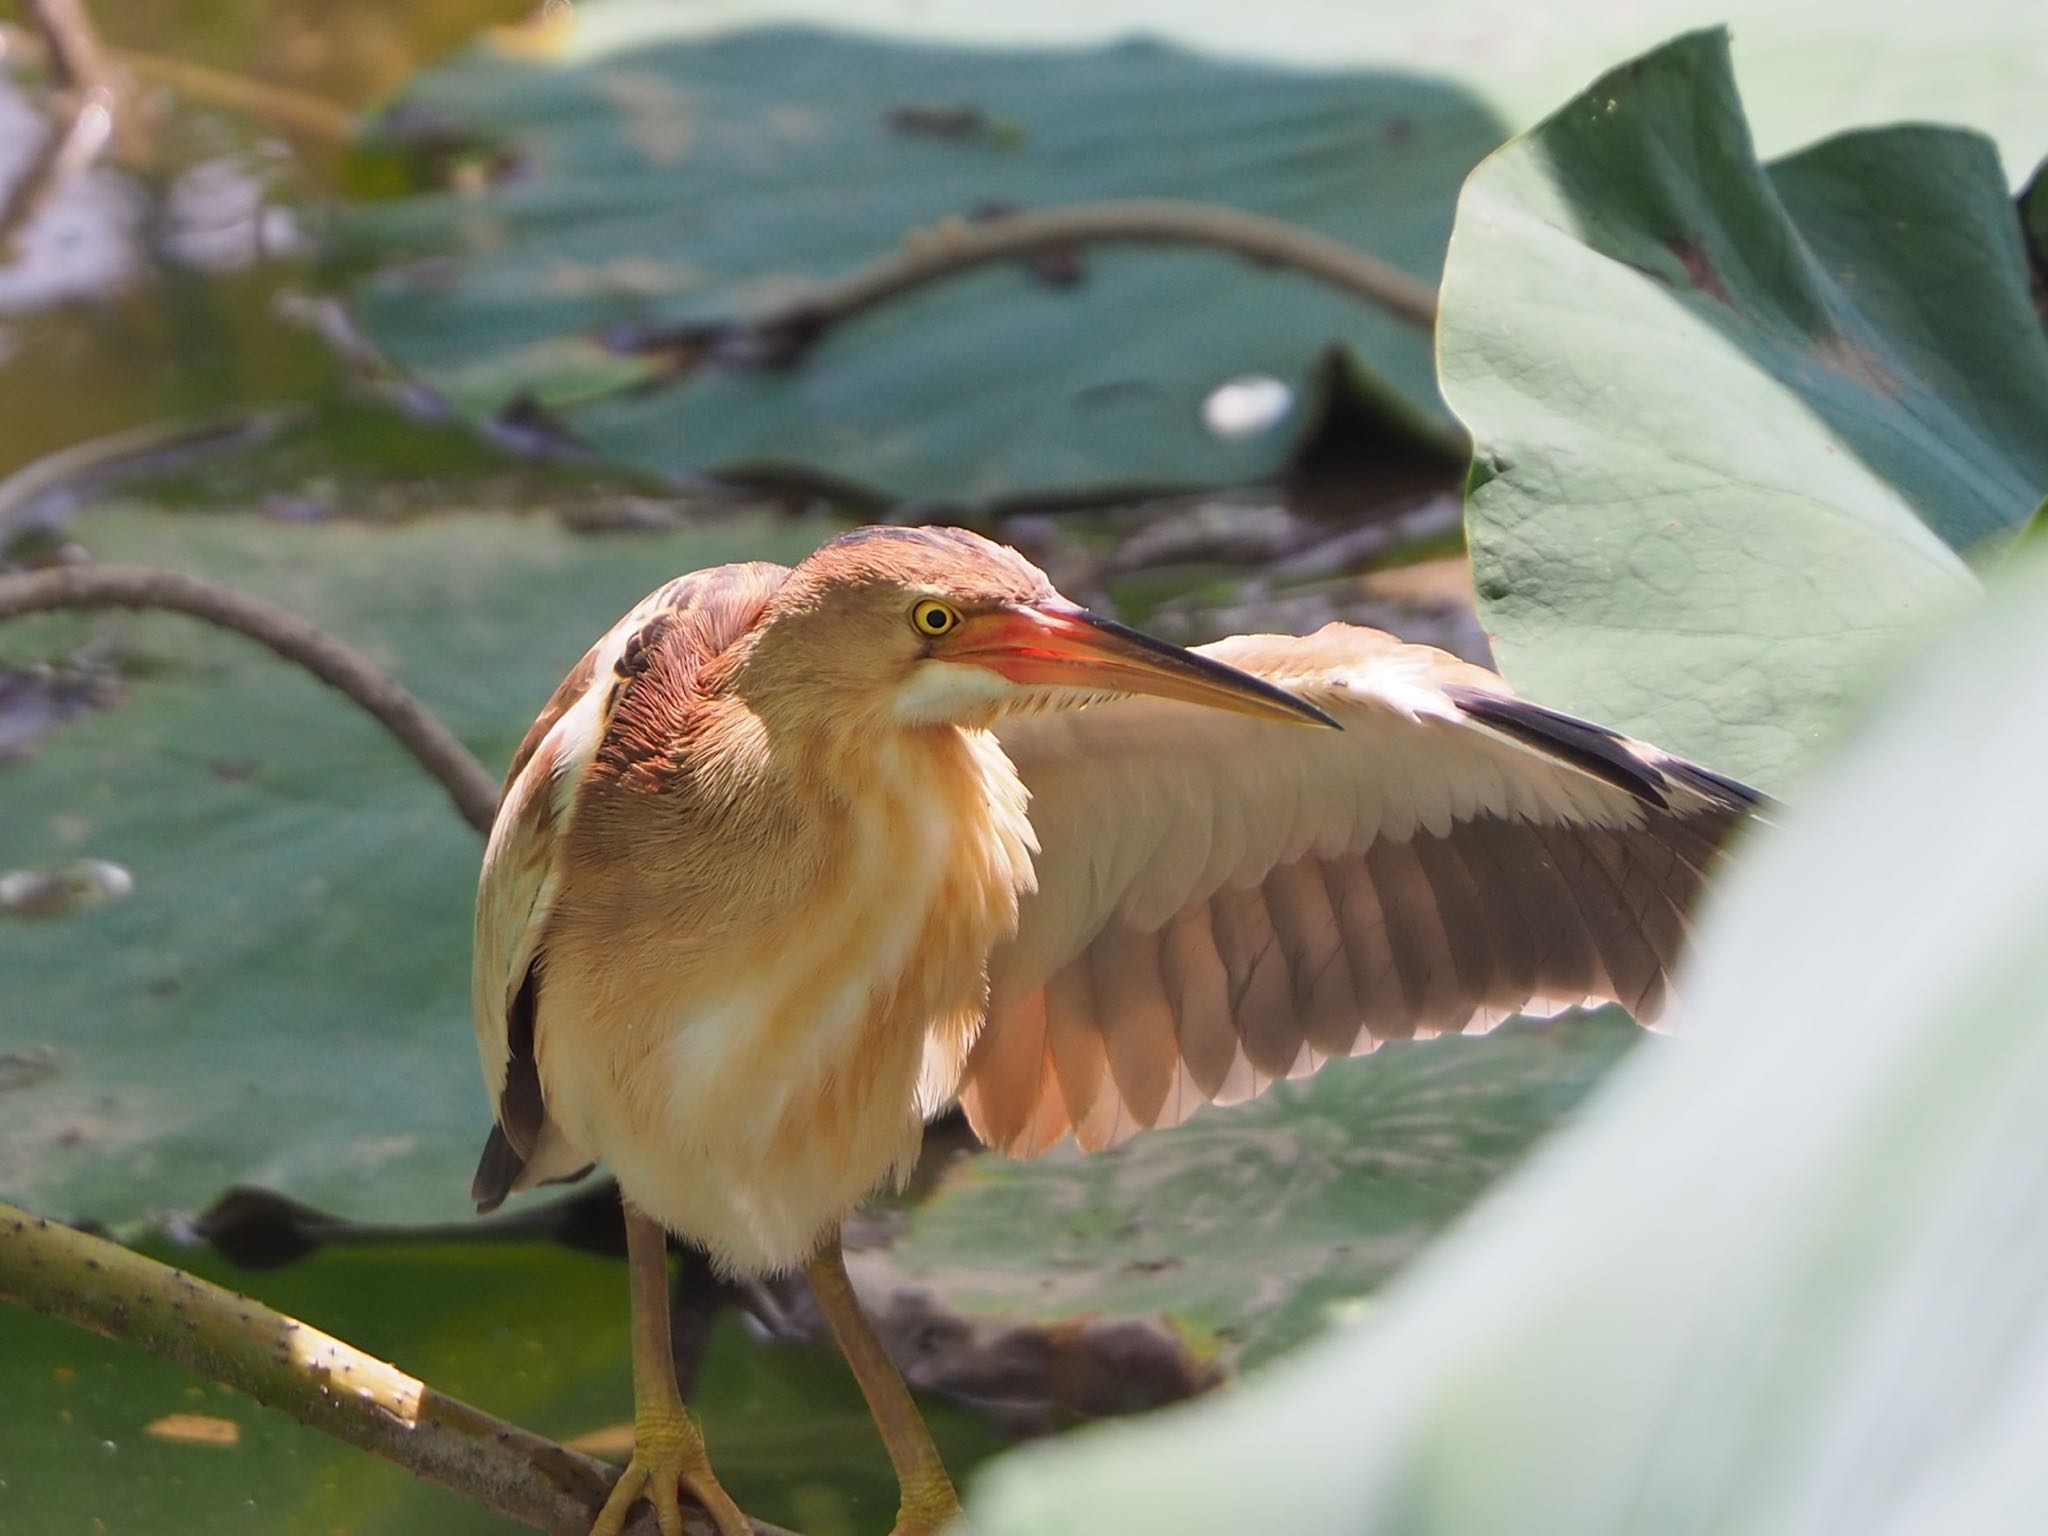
659, 199, 1436, 358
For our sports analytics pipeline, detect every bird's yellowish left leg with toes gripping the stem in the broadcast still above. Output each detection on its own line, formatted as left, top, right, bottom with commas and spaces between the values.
590, 1204, 754, 1536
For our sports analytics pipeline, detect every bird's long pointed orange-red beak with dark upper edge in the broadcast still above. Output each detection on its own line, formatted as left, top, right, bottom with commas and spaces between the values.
932, 604, 1339, 729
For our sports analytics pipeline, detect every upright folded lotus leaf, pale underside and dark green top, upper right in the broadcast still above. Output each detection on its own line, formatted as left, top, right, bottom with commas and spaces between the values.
1440, 33, 2048, 791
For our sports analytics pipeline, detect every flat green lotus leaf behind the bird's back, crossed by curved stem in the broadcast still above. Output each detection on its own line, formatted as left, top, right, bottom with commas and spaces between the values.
0, 514, 831, 1221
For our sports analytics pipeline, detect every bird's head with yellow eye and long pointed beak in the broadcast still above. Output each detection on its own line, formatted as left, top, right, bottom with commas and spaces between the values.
752, 528, 1333, 725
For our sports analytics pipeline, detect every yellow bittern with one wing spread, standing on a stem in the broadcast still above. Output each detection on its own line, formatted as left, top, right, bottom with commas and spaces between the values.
475, 528, 1755, 1536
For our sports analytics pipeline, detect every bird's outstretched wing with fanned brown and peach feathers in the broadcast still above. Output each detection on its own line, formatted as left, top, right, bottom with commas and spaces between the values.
961, 625, 1759, 1155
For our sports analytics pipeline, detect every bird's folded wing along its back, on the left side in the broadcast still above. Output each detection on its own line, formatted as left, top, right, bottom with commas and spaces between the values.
471, 563, 788, 1210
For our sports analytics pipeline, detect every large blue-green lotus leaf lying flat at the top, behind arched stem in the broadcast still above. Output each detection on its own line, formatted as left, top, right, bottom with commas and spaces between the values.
340, 22, 1503, 498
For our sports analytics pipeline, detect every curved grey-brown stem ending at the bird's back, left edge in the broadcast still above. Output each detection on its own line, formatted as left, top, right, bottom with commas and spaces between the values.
0, 565, 498, 834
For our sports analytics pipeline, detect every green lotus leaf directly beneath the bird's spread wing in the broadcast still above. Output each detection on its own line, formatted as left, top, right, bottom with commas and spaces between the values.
891, 1010, 1638, 1366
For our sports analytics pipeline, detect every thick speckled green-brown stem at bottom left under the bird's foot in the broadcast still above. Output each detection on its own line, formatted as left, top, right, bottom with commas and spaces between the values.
0, 1204, 788, 1536
